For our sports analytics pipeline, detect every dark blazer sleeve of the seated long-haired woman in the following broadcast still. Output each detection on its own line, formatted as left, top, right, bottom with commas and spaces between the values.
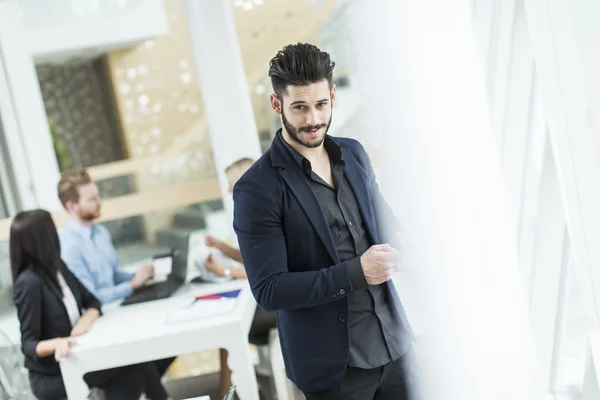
13, 276, 42, 360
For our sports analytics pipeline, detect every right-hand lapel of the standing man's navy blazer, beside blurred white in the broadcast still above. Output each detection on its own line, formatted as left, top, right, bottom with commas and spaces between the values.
342, 148, 379, 243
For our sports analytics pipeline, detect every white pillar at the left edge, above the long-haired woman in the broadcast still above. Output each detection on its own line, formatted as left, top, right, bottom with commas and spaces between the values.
0, 0, 61, 211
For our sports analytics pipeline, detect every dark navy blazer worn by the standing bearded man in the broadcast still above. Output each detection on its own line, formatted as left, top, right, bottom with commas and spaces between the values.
233, 135, 409, 392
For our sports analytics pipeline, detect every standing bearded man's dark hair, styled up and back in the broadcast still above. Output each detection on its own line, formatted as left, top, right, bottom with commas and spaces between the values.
269, 43, 335, 101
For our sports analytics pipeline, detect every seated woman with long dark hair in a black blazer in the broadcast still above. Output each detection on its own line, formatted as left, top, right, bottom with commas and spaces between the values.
10, 210, 168, 400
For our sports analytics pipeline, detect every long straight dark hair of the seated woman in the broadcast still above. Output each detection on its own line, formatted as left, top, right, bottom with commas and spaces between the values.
10, 210, 61, 287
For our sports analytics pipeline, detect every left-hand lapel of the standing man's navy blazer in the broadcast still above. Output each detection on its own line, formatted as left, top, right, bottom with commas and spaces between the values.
282, 168, 340, 264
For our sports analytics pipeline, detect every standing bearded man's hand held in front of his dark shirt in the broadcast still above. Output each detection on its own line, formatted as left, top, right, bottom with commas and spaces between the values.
360, 244, 399, 285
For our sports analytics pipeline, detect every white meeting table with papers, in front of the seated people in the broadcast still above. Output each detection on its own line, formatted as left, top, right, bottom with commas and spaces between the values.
60, 280, 258, 400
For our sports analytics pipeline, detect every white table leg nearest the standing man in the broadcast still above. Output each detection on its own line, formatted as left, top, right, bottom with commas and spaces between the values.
227, 333, 259, 400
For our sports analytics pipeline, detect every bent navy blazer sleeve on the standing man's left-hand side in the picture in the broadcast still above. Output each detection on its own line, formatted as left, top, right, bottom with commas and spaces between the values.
233, 175, 357, 311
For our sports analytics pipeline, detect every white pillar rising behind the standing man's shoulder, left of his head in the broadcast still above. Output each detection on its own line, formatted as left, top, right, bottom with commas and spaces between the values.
184, 0, 268, 233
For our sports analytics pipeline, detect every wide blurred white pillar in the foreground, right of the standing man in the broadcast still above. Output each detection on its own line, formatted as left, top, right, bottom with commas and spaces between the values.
351, 0, 541, 400
